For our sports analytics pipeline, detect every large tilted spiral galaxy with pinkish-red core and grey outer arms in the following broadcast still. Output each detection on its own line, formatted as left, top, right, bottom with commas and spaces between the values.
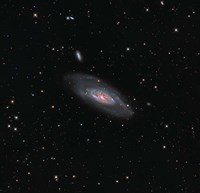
64, 73, 134, 118
